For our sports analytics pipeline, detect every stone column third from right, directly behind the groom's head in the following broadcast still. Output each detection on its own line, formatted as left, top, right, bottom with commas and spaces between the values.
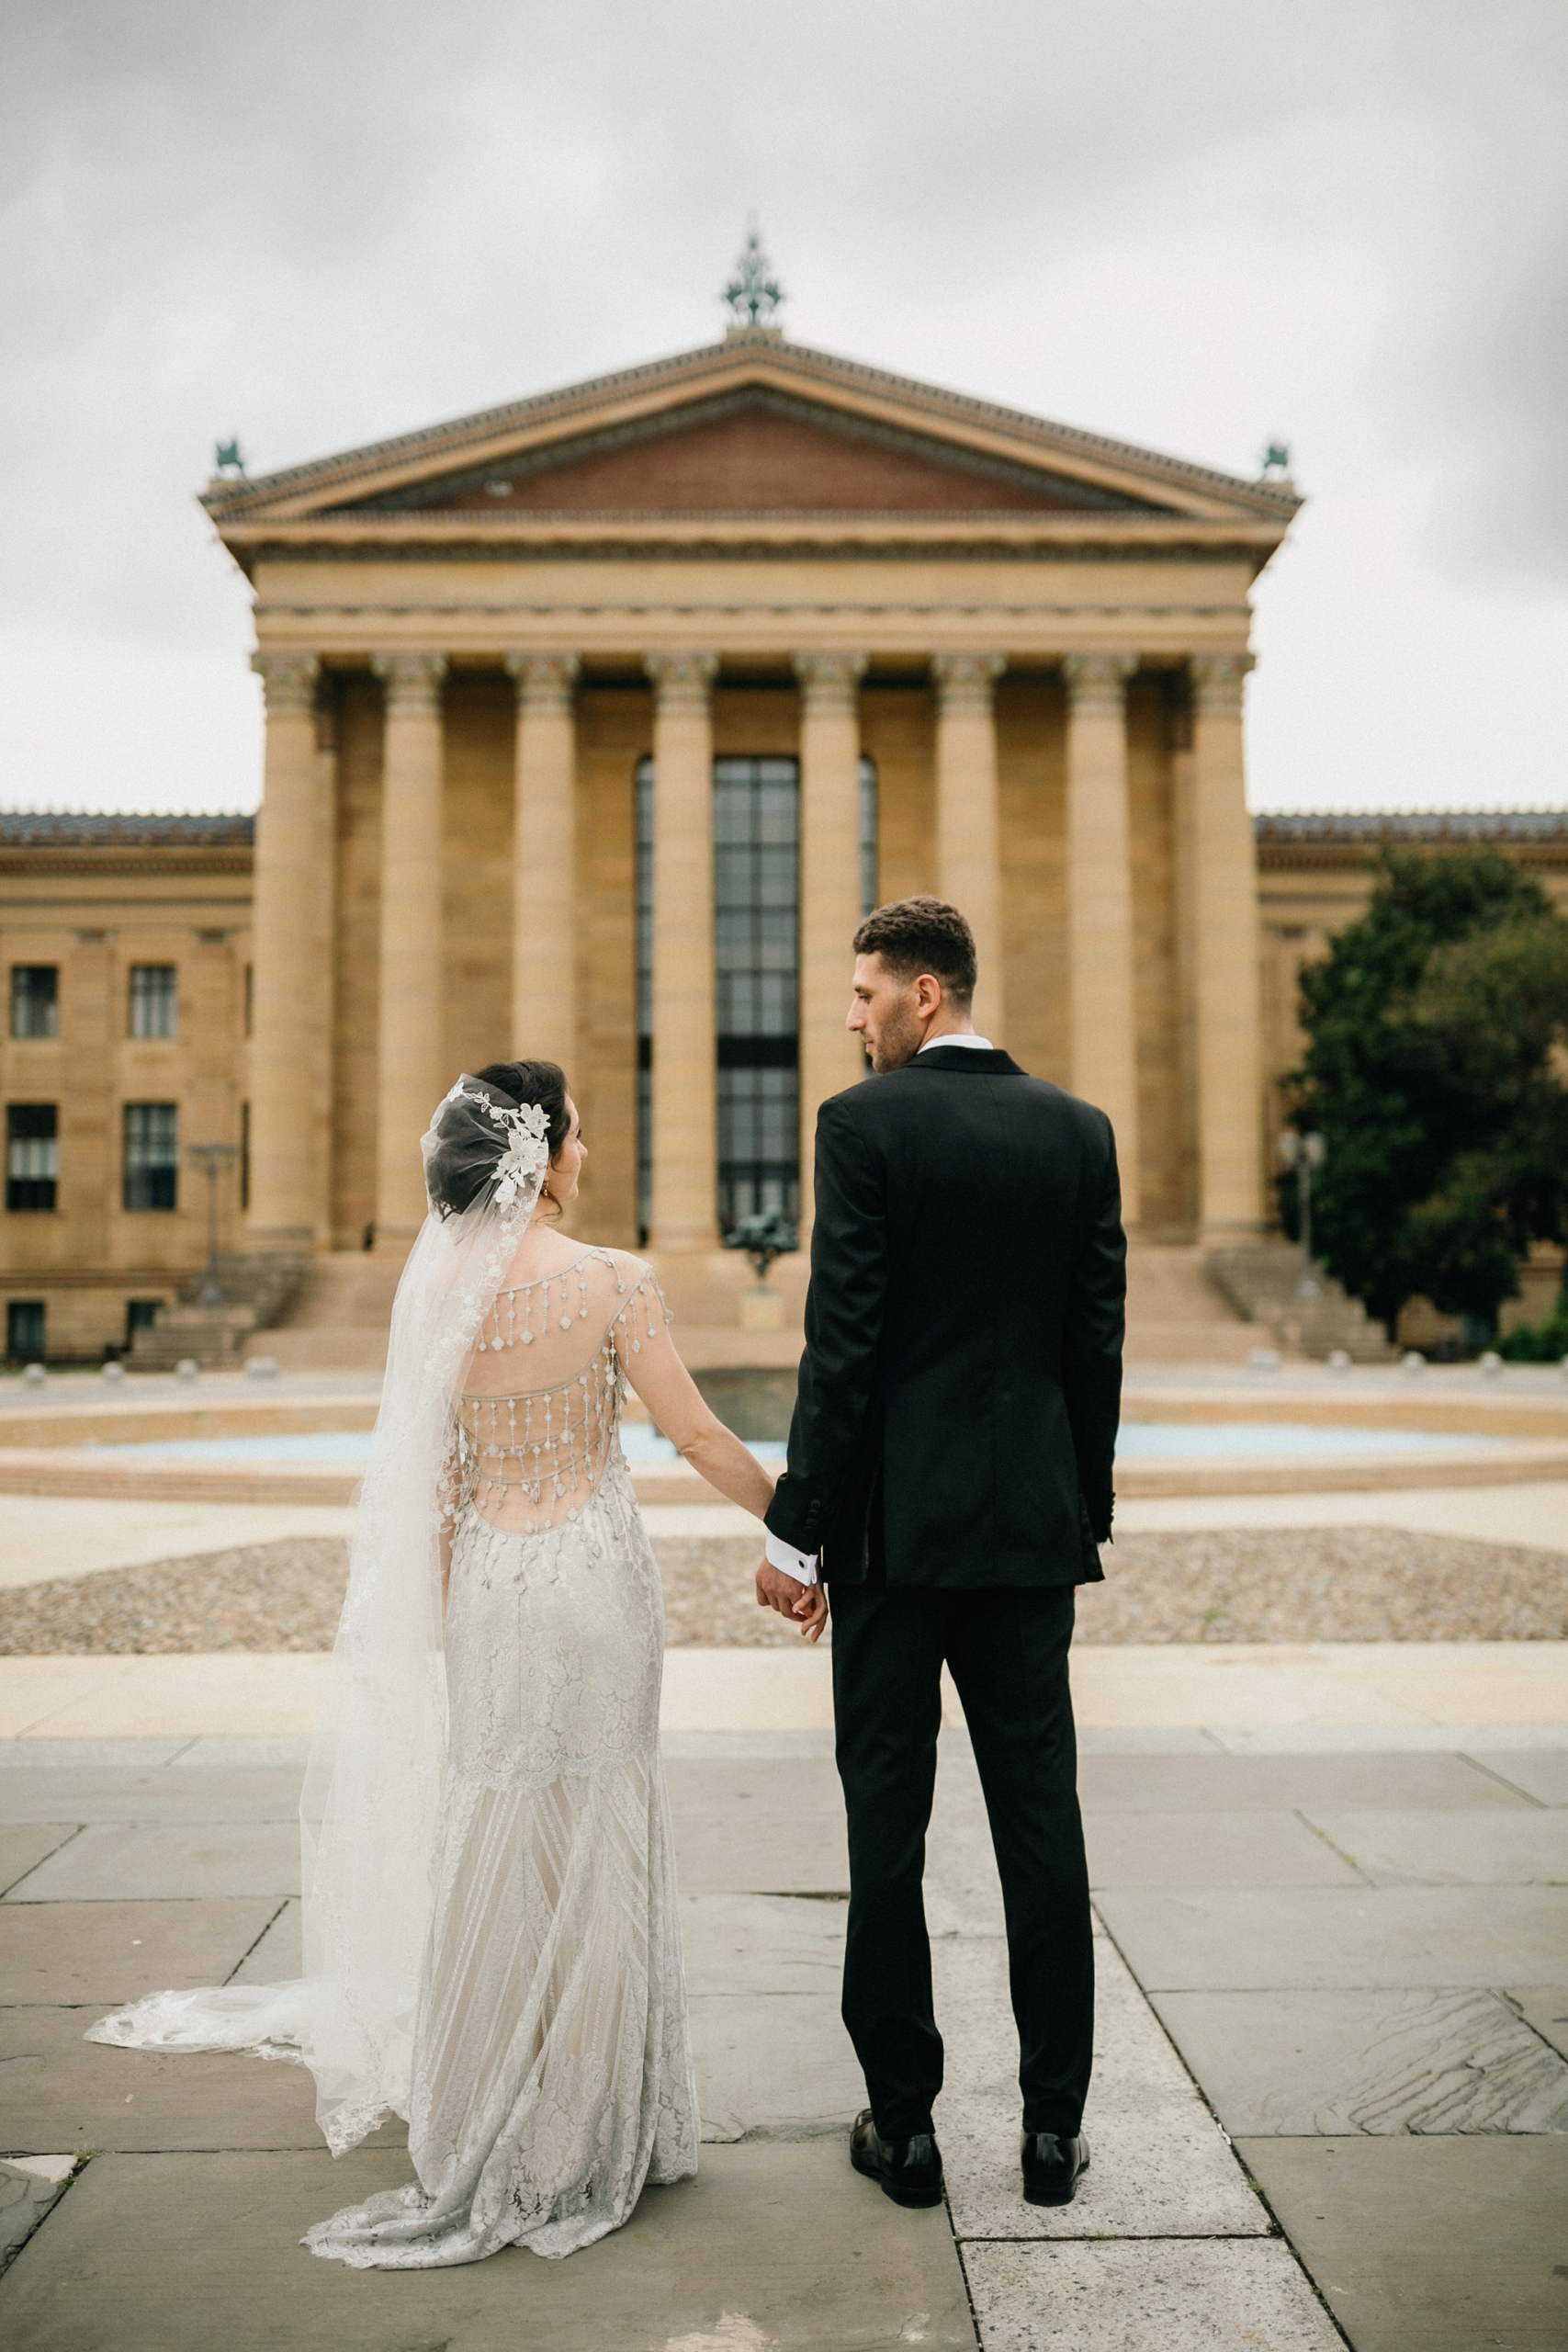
931, 654, 1006, 1045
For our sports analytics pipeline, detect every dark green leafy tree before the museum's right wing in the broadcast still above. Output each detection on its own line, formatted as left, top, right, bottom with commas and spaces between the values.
1281, 854, 1568, 1327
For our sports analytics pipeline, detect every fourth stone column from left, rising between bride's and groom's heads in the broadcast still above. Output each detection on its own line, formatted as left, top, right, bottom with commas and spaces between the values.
644, 654, 719, 1249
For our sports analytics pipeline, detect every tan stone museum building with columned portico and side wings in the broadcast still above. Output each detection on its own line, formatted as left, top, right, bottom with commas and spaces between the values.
0, 324, 1568, 1357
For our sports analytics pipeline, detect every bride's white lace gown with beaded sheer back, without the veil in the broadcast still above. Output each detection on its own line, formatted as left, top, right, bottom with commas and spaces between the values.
306, 1251, 698, 2269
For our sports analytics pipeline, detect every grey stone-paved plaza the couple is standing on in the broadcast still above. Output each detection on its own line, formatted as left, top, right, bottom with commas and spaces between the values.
0, 1712, 1568, 2352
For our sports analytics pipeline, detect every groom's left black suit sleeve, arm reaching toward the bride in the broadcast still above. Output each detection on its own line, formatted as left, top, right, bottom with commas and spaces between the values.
766, 1096, 888, 1553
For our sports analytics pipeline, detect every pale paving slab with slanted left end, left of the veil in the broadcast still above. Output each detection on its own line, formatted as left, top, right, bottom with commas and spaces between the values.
0, 1820, 299, 1907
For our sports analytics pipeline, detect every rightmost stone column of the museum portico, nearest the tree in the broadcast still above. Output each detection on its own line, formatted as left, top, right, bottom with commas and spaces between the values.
1190, 654, 1262, 1247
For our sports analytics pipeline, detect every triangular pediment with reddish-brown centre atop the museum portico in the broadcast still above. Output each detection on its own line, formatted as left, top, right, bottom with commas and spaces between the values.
205, 332, 1298, 532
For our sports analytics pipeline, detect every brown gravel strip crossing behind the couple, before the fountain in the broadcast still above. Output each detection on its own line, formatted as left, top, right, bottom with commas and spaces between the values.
0, 1526, 1568, 1658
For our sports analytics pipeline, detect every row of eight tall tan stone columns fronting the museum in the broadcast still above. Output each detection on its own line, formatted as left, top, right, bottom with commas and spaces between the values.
249, 651, 1262, 1251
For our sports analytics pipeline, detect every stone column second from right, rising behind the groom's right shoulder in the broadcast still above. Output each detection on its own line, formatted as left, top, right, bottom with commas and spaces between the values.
1063, 654, 1138, 1226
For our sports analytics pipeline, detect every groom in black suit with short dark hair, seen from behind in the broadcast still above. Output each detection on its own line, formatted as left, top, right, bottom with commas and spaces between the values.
757, 899, 1126, 2206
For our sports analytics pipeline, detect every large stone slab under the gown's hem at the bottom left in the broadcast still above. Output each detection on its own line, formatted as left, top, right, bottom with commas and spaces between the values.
0, 2141, 982, 2352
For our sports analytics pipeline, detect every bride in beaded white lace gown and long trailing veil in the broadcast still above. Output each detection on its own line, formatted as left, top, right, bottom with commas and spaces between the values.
87, 1061, 823, 2269
